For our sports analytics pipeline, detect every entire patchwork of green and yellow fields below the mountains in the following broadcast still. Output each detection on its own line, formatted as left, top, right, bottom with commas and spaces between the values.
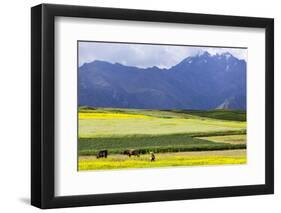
78, 107, 246, 170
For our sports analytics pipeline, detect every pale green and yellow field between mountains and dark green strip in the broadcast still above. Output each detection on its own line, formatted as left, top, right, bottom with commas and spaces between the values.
79, 109, 246, 138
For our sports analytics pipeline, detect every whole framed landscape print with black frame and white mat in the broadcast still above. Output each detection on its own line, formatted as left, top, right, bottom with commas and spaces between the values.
31, 4, 274, 208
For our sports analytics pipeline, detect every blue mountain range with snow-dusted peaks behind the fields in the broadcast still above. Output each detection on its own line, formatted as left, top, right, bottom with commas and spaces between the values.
78, 52, 246, 110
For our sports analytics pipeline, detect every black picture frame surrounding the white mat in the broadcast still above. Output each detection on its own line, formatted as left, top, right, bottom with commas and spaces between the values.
31, 4, 274, 209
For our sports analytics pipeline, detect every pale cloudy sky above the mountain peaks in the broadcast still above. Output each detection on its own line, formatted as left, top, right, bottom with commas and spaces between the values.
78, 42, 247, 68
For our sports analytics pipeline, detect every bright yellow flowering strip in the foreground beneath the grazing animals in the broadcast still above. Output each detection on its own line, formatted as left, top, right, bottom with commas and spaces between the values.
78, 150, 247, 171
